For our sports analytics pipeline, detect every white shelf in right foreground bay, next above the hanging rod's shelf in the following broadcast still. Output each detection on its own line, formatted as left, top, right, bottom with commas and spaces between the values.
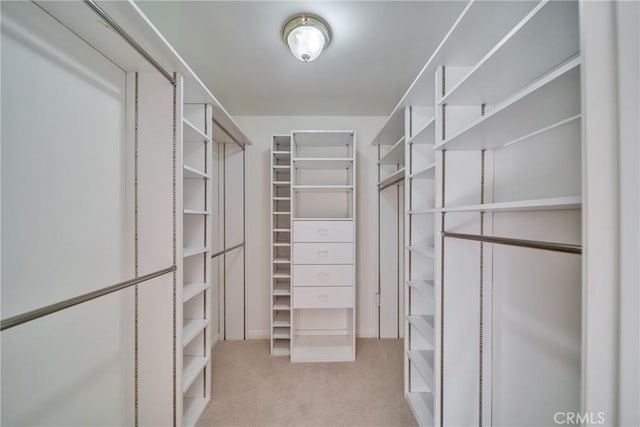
435, 57, 581, 150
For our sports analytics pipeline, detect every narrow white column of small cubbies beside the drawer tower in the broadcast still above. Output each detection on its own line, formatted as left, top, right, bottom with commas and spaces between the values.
270, 135, 292, 356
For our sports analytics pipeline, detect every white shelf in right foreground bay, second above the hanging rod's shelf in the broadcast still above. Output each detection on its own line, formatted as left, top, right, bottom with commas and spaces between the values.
441, 1, 579, 105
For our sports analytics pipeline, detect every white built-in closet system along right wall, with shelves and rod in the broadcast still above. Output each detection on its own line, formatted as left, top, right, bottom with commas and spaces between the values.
375, 1, 582, 425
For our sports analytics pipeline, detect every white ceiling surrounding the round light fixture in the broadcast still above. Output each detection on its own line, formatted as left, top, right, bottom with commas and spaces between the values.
137, 1, 465, 116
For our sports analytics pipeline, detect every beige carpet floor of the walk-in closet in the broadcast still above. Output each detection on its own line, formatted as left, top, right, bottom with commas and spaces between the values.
198, 339, 416, 427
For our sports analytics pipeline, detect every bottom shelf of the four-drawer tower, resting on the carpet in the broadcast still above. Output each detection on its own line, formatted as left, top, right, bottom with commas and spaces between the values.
291, 335, 355, 362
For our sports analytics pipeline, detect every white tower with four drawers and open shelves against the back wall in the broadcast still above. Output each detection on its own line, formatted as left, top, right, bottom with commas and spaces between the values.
290, 131, 356, 362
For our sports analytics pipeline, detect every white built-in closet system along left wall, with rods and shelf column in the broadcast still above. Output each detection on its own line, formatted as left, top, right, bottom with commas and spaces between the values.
0, 1, 248, 426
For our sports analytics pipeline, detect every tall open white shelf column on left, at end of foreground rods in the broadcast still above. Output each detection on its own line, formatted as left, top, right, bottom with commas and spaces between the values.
178, 104, 213, 426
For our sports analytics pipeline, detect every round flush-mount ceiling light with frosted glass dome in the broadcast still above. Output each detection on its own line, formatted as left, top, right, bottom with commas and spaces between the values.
282, 13, 331, 62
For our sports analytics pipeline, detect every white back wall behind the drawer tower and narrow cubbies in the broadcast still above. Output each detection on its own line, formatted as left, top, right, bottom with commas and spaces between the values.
235, 116, 385, 339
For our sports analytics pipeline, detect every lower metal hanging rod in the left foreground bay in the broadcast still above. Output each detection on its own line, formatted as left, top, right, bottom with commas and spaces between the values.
0, 265, 176, 331
